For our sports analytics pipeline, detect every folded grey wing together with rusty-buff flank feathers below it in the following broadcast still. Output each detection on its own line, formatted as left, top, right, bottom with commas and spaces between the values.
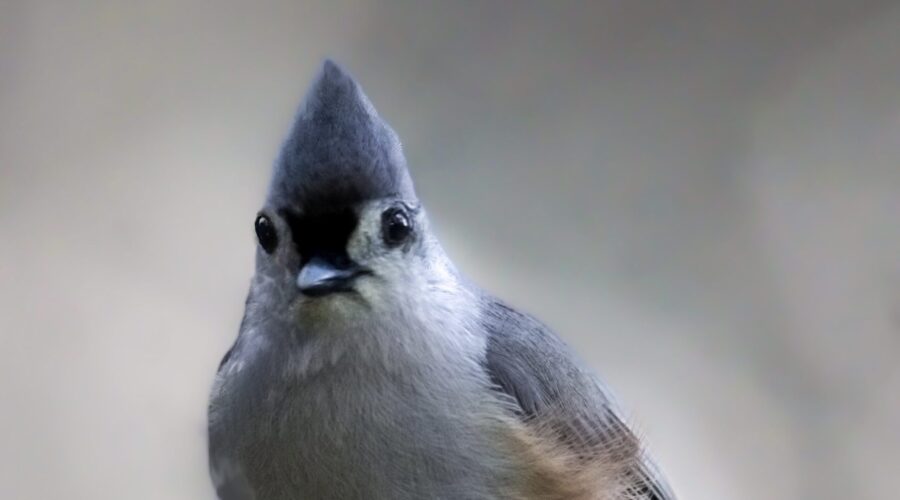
482, 295, 675, 500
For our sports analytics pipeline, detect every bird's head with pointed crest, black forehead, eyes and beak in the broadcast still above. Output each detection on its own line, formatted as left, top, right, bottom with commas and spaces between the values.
251, 61, 444, 324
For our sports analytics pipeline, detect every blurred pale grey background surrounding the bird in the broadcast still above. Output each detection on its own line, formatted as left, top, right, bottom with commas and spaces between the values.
0, 0, 900, 500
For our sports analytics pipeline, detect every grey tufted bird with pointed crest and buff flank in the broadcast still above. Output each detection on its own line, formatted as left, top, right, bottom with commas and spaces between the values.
208, 59, 675, 500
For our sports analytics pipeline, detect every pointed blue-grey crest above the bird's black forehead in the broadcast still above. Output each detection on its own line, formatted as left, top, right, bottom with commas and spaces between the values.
269, 61, 415, 211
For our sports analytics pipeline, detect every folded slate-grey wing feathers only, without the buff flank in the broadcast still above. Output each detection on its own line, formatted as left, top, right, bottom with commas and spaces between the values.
482, 295, 675, 500
